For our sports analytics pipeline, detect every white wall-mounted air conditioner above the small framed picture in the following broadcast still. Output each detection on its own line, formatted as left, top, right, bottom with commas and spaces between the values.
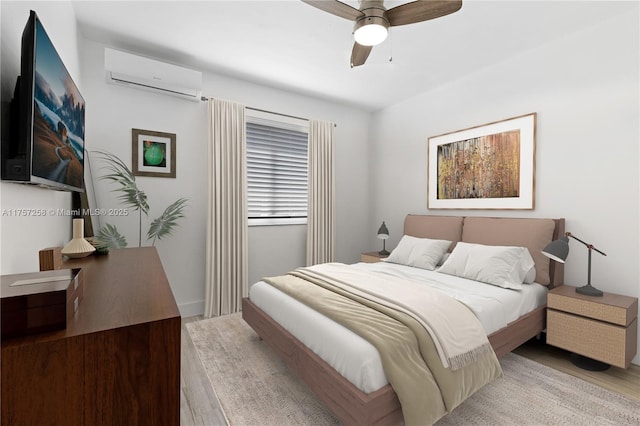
104, 48, 202, 101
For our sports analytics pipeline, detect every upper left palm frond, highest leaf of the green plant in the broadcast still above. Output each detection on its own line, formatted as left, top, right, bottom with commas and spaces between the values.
95, 151, 149, 215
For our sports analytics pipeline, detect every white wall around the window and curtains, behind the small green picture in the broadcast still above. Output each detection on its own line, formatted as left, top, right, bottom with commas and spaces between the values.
82, 40, 371, 316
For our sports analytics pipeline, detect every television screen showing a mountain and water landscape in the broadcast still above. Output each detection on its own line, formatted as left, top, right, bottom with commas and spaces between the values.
31, 19, 85, 190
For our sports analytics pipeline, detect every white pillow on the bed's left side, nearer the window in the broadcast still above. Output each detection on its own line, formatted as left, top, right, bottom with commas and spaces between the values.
387, 235, 451, 271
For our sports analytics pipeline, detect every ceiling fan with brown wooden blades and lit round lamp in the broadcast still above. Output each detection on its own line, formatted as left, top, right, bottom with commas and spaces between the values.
302, 0, 462, 68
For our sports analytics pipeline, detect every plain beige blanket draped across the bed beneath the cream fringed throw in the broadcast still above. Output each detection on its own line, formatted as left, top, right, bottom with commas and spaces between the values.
264, 266, 502, 426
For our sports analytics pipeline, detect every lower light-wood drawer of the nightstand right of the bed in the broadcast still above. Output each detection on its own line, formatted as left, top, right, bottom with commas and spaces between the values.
547, 309, 638, 368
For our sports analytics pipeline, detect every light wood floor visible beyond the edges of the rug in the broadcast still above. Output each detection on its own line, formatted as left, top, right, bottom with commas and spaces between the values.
180, 316, 640, 426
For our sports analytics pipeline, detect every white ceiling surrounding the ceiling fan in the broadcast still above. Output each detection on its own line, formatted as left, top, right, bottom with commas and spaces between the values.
73, 0, 638, 111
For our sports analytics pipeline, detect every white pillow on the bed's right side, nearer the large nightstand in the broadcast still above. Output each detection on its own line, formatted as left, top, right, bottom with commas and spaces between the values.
438, 242, 534, 290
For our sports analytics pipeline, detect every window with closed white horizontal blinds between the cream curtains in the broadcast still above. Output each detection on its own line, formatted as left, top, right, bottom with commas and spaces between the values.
246, 110, 309, 225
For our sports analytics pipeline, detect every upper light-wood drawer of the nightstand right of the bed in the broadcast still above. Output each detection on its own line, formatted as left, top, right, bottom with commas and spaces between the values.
547, 286, 638, 326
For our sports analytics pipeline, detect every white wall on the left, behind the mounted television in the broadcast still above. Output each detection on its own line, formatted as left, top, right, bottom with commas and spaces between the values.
0, 1, 84, 274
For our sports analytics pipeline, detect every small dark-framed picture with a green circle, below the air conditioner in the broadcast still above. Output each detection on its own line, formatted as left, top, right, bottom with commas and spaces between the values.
131, 129, 176, 178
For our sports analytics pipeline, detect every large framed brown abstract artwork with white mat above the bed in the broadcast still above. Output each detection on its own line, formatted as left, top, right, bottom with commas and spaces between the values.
427, 113, 537, 210
